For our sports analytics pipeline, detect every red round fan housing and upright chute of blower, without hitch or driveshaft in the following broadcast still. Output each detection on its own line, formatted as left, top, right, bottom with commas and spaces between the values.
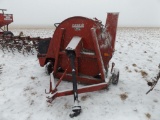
38, 13, 118, 84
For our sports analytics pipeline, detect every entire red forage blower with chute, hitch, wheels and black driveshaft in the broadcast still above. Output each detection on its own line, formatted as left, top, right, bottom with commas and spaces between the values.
38, 13, 119, 117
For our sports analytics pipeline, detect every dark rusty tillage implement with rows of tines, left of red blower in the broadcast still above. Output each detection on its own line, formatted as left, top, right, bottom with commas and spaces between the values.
0, 36, 51, 55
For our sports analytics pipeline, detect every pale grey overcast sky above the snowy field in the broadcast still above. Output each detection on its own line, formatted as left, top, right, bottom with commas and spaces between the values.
0, 0, 160, 27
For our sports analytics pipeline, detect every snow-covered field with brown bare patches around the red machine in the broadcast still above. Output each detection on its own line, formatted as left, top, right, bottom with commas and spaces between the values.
0, 28, 160, 120
